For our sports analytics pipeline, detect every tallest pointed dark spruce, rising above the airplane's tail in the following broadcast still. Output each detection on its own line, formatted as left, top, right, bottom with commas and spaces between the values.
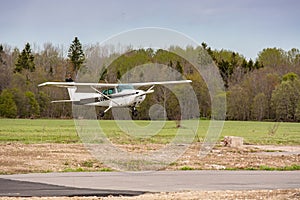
68, 37, 85, 78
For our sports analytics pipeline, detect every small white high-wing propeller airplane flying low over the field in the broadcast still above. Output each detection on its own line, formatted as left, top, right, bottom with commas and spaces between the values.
38, 80, 192, 117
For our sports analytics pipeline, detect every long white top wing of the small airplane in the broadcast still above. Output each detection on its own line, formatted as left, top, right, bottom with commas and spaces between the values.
38, 80, 192, 88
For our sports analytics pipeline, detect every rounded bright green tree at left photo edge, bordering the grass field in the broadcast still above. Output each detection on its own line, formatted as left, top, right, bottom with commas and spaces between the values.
0, 89, 17, 118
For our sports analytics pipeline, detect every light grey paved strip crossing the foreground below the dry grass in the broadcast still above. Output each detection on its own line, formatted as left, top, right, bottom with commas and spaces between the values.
0, 170, 300, 196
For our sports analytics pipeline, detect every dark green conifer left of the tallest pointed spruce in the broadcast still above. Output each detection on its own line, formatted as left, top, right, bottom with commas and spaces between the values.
15, 43, 35, 72
